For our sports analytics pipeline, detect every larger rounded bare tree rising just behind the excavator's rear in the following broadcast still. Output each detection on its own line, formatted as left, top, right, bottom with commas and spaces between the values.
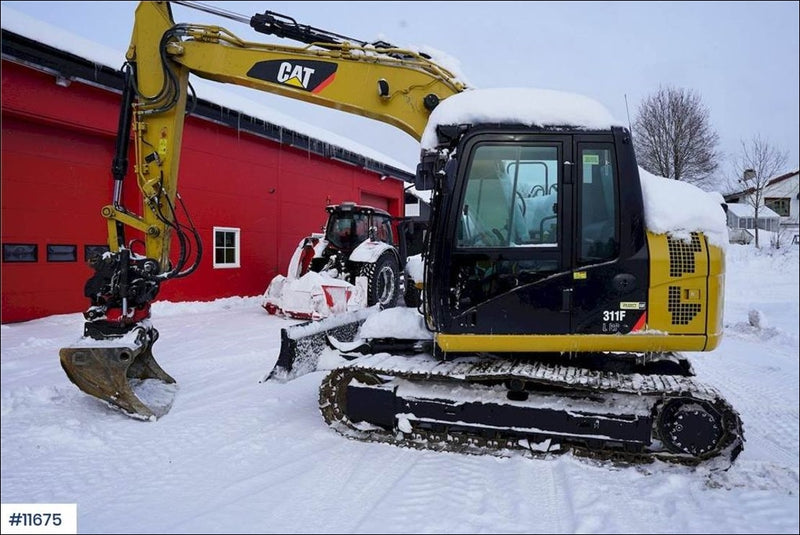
633, 87, 719, 182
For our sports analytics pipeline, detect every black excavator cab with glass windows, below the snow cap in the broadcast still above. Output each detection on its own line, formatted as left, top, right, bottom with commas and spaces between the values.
425, 127, 648, 351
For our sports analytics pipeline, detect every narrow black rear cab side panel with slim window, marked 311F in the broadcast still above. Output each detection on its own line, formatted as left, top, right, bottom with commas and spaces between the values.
570, 134, 648, 334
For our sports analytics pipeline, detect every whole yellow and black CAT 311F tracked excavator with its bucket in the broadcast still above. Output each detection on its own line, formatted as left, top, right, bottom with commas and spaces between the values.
60, 2, 744, 469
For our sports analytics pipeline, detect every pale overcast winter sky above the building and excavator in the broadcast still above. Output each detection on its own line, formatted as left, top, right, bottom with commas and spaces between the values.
2, 2, 800, 188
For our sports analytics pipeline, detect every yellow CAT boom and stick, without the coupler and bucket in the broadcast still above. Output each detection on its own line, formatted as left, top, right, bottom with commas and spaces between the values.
123, 2, 464, 270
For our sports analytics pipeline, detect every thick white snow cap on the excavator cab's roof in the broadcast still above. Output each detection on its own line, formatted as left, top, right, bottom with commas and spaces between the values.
422, 87, 624, 150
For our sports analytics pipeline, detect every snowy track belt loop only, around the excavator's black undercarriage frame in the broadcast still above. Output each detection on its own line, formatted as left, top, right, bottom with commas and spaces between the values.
319, 354, 744, 470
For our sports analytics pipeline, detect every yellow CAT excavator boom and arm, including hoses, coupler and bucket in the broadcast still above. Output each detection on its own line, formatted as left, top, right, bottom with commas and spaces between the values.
60, 2, 465, 419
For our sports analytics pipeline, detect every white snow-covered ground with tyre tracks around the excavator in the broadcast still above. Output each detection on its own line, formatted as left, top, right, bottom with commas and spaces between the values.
0, 245, 800, 533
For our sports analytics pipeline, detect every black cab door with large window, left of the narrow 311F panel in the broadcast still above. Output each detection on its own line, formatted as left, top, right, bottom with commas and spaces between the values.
426, 130, 574, 334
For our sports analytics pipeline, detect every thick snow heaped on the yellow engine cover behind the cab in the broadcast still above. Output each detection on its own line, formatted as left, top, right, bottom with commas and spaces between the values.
639, 167, 728, 250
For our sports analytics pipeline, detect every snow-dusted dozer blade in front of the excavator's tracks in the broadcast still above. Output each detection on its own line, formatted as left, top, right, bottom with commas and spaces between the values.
259, 305, 380, 383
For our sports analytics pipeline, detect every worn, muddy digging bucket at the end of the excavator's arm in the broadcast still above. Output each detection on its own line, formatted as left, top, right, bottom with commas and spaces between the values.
59, 327, 178, 420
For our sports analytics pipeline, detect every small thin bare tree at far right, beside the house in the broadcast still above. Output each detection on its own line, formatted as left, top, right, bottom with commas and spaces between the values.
733, 135, 787, 248
